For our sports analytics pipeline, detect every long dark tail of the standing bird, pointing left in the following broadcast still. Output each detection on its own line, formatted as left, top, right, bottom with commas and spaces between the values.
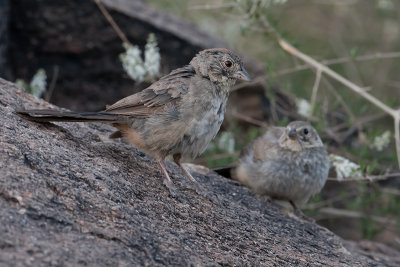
15, 109, 127, 123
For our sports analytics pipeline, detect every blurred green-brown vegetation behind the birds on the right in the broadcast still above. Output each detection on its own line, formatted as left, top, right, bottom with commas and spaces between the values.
148, 0, 400, 248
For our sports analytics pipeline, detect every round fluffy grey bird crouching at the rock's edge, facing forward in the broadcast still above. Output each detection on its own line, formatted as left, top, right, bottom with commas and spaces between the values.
231, 121, 330, 214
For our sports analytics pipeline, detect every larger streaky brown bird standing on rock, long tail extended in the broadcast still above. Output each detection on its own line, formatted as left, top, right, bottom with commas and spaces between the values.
17, 48, 250, 195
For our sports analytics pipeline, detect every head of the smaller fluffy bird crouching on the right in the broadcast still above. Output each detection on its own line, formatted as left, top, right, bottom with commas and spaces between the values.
279, 121, 323, 151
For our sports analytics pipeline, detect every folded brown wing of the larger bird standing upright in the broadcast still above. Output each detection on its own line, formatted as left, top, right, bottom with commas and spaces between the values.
105, 65, 196, 117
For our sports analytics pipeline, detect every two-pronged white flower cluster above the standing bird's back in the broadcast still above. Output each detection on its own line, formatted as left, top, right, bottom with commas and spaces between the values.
119, 34, 161, 82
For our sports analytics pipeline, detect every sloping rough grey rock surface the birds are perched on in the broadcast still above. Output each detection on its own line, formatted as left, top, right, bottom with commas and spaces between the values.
0, 79, 387, 266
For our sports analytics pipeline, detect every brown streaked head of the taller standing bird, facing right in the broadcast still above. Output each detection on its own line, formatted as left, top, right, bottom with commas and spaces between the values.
190, 48, 250, 87
